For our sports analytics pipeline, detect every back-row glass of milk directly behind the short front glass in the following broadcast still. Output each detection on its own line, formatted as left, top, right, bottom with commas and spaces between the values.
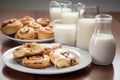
61, 4, 79, 24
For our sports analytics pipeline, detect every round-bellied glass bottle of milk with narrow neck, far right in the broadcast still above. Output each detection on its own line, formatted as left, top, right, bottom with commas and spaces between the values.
89, 14, 116, 65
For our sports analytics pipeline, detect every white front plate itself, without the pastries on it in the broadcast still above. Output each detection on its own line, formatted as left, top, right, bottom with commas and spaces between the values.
2, 45, 92, 75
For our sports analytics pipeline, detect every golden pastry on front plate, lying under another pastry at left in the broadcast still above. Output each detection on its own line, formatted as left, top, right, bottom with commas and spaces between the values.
22, 54, 51, 68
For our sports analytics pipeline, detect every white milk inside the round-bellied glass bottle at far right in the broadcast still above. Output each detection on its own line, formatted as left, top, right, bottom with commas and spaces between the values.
89, 34, 116, 65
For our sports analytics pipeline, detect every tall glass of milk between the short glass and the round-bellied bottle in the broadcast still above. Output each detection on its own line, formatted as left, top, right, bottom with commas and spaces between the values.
76, 5, 99, 51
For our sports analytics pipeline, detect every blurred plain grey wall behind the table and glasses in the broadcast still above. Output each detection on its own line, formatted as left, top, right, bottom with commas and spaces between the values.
0, 0, 120, 12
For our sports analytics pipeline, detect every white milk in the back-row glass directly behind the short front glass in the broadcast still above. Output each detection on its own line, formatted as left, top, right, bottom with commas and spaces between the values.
61, 11, 78, 24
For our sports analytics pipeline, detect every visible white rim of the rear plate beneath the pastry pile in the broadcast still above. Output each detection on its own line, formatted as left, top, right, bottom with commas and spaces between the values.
3, 34, 54, 43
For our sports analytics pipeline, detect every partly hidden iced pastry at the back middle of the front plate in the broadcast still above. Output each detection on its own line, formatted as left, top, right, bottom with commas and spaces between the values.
43, 43, 62, 55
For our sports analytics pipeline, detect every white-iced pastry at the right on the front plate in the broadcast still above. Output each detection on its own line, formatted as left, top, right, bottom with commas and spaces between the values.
50, 48, 78, 68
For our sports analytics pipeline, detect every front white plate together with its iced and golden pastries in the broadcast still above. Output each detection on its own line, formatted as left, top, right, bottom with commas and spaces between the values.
2, 42, 92, 75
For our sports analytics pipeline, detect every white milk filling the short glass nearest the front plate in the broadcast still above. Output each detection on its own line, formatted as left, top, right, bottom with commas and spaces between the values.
54, 24, 76, 45
